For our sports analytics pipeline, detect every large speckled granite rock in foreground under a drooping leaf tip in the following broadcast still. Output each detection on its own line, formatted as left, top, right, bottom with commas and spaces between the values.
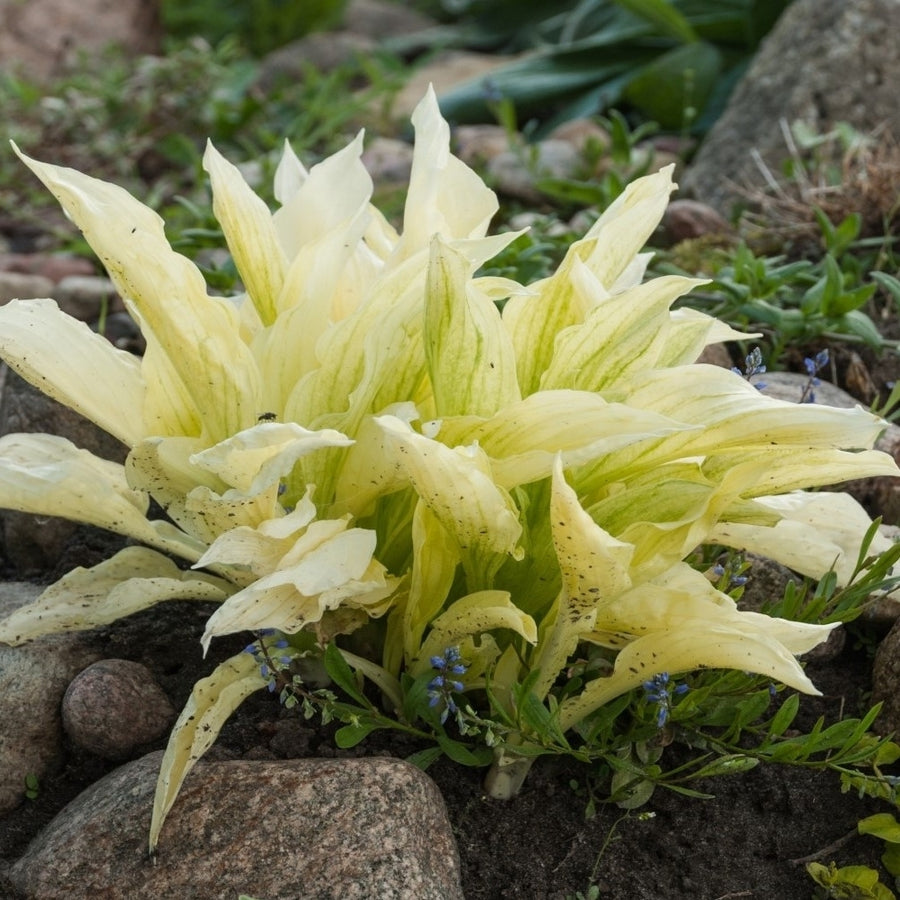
8, 753, 462, 900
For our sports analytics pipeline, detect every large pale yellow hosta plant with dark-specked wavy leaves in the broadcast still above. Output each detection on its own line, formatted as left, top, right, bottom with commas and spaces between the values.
0, 92, 896, 846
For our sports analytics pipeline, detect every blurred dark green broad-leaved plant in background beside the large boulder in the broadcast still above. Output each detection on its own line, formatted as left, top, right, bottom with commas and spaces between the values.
432, 0, 791, 136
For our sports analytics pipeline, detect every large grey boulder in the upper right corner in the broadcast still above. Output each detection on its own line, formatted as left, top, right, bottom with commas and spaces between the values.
681, 0, 900, 213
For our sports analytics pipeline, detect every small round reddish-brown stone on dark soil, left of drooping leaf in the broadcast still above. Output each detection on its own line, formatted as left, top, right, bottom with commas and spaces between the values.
62, 659, 175, 760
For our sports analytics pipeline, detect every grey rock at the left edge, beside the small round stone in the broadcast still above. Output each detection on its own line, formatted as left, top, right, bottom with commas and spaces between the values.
0, 582, 101, 815
